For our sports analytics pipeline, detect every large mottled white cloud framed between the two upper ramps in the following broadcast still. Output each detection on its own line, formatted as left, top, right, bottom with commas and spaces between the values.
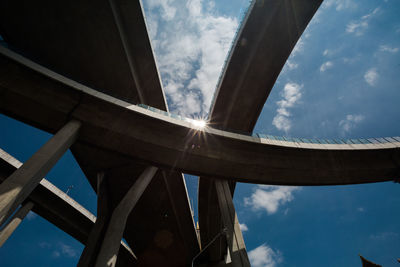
144, 0, 238, 116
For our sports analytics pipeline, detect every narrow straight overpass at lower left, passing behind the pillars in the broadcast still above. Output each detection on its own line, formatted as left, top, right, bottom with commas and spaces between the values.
0, 149, 136, 266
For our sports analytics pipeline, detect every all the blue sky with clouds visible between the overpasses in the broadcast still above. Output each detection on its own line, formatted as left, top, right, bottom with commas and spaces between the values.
0, 0, 400, 267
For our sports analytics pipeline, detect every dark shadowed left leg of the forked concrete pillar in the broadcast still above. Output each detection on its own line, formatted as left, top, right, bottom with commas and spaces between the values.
77, 172, 111, 267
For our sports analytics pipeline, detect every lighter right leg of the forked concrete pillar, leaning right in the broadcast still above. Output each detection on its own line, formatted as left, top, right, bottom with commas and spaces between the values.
95, 167, 158, 267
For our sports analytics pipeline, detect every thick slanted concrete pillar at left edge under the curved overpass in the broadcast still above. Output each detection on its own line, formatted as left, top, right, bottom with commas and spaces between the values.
0, 120, 81, 225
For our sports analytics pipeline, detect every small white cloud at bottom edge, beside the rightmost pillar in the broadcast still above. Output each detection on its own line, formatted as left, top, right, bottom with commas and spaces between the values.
248, 244, 283, 267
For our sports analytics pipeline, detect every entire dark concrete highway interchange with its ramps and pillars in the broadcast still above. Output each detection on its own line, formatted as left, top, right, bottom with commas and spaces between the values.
0, 0, 400, 266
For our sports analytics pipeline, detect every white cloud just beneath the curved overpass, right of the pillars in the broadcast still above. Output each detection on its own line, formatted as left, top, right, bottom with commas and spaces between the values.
244, 185, 300, 215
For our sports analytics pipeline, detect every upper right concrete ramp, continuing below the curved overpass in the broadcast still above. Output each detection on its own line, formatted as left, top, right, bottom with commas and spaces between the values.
199, 0, 322, 260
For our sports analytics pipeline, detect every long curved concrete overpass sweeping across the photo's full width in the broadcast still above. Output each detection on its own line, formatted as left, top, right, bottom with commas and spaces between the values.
0, 48, 400, 188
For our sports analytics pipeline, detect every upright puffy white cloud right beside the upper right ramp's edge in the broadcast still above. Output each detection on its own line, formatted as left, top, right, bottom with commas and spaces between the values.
272, 83, 303, 132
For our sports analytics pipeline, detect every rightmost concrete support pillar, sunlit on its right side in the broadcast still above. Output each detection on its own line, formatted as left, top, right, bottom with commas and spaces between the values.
215, 180, 250, 267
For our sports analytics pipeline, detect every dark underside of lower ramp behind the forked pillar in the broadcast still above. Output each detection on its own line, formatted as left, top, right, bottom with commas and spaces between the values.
72, 145, 199, 266
